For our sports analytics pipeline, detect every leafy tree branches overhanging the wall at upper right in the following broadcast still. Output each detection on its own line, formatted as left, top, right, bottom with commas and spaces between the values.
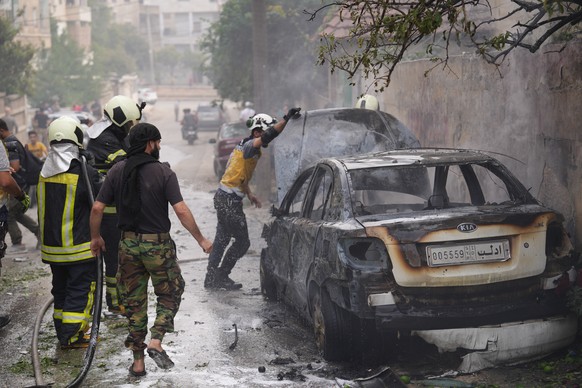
305, 0, 582, 91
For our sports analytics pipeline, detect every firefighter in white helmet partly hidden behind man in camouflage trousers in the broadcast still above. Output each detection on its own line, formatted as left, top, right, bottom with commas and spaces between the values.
87, 96, 145, 316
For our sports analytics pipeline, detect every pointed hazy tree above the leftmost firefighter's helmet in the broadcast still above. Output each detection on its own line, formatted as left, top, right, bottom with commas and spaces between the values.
30, 21, 101, 106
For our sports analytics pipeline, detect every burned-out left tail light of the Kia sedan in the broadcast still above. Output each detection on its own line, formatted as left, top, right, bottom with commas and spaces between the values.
338, 237, 391, 271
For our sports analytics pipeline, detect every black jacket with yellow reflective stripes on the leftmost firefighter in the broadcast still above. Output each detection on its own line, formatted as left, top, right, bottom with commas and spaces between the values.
36, 160, 99, 265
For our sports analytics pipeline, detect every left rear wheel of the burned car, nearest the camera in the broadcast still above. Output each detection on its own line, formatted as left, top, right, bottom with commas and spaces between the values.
311, 290, 357, 361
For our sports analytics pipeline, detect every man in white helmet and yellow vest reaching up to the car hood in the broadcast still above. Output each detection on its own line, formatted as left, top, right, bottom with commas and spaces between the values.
204, 108, 301, 290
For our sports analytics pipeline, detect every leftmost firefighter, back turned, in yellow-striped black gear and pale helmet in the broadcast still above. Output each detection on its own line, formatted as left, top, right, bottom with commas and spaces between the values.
37, 116, 99, 349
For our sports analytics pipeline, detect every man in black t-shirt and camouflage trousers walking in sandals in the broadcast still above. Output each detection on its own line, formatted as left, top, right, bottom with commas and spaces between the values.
90, 123, 212, 377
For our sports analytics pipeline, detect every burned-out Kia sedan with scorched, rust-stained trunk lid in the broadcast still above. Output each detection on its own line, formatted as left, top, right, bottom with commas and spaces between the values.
260, 148, 576, 360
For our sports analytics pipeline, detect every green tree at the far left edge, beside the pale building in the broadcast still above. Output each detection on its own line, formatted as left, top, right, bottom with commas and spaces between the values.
0, 17, 35, 94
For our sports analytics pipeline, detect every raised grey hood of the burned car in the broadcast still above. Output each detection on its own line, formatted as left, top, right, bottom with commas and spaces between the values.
272, 108, 420, 203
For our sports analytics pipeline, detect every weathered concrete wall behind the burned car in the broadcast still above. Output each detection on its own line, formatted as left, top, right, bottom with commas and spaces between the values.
379, 41, 582, 250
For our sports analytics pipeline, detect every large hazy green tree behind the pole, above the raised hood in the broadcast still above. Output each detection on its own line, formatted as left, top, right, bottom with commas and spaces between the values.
201, 0, 327, 109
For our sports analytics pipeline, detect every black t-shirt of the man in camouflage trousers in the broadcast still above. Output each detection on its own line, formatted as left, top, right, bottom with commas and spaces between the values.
97, 160, 183, 233
